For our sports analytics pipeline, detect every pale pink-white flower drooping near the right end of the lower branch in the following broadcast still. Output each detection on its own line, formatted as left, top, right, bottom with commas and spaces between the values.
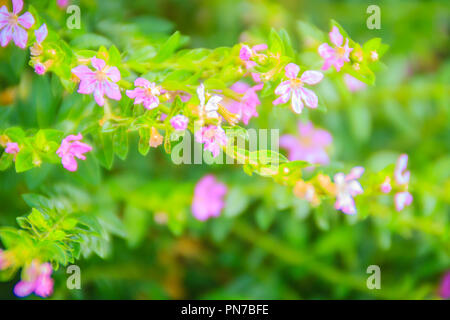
334, 167, 364, 214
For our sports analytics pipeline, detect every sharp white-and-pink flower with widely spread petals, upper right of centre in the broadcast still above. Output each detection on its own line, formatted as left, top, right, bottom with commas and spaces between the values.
273, 63, 323, 113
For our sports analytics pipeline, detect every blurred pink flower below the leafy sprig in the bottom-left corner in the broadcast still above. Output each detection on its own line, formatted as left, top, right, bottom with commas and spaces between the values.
14, 261, 54, 298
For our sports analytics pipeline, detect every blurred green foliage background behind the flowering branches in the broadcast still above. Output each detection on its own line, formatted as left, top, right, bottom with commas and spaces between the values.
0, 0, 450, 299
